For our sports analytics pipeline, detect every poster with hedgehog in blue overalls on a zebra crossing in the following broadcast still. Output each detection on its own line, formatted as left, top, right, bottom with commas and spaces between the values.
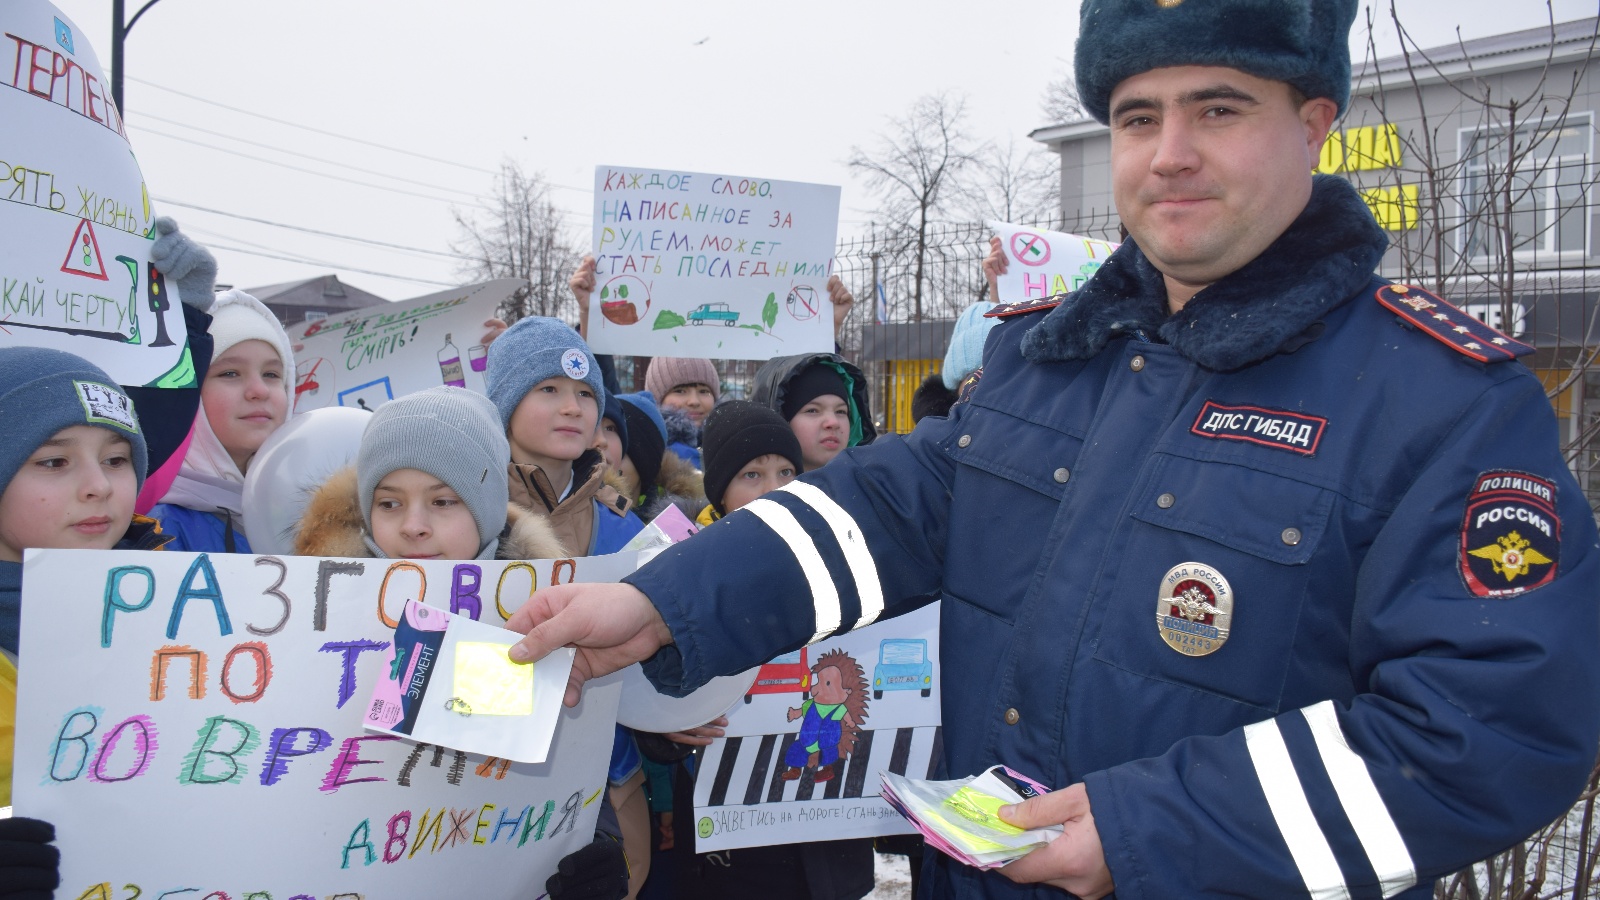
694, 604, 942, 854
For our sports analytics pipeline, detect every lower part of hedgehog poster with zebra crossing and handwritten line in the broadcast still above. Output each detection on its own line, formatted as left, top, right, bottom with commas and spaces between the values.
694, 725, 944, 852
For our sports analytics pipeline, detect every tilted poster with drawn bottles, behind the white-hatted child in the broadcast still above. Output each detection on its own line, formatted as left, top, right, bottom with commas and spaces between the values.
290, 279, 528, 413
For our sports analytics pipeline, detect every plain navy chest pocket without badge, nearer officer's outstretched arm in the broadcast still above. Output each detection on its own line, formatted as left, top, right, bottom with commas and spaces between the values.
944, 407, 1083, 625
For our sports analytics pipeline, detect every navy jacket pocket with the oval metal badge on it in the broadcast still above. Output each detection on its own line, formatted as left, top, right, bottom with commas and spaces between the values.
1094, 456, 1334, 714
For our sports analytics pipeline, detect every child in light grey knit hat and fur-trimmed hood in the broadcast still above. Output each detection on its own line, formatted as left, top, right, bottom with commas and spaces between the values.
294, 386, 563, 559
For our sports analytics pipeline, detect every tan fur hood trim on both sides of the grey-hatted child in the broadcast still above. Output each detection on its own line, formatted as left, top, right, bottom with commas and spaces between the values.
294, 466, 571, 559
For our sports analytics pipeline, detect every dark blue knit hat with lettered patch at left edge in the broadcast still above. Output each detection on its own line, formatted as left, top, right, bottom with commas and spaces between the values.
0, 348, 149, 493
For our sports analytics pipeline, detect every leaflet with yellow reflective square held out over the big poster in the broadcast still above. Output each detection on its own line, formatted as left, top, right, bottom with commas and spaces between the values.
363, 601, 574, 762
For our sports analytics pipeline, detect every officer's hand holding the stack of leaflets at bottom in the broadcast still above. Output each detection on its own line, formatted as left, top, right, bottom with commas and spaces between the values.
1000, 783, 1114, 900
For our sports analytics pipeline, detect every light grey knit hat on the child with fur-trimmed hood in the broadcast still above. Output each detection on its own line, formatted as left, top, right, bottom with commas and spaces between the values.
355, 386, 510, 554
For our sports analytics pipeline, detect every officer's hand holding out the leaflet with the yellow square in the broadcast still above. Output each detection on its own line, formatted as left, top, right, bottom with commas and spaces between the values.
506, 583, 672, 706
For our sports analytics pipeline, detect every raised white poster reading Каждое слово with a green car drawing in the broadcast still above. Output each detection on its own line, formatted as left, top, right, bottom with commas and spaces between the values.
589, 165, 838, 359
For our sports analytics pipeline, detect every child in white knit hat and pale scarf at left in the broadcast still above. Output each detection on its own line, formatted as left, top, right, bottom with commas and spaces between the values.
150, 290, 294, 552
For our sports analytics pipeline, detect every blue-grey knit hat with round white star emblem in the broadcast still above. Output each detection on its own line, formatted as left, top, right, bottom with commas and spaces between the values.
483, 315, 605, 429
